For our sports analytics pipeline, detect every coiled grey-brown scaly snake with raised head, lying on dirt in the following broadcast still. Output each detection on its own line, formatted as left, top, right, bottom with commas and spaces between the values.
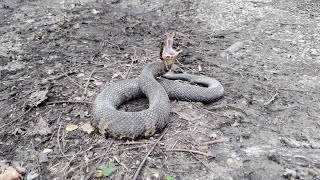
92, 32, 224, 139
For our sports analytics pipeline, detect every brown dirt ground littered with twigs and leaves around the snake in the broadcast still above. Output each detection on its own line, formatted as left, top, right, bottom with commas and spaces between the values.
0, 0, 320, 180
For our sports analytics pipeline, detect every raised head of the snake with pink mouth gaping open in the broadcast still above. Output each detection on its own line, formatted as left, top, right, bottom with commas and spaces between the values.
160, 32, 182, 71
